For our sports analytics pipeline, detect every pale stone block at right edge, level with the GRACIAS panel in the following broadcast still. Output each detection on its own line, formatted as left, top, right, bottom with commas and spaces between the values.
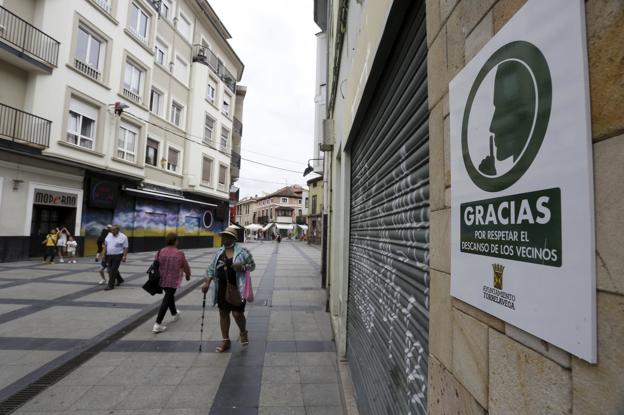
594, 135, 624, 294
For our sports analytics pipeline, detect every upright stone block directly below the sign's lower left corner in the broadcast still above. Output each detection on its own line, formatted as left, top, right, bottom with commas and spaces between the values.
453, 309, 488, 408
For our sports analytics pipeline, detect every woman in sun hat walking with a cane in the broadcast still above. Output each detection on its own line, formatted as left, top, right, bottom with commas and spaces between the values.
202, 226, 256, 353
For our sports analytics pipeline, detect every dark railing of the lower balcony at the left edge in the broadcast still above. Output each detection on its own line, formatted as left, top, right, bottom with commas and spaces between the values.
0, 104, 52, 147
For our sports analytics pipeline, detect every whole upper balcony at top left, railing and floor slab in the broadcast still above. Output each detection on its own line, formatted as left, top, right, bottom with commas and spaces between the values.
0, 6, 60, 73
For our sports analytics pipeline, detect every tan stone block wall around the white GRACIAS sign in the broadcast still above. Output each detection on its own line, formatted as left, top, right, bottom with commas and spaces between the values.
427, 0, 624, 415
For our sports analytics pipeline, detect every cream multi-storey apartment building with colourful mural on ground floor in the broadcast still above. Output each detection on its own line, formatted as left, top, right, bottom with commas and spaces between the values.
0, 0, 246, 261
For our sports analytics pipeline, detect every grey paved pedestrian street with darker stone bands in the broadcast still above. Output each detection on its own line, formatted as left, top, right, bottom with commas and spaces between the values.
0, 241, 342, 415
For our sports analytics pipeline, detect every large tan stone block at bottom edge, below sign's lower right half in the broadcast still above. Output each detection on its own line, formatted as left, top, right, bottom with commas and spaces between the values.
489, 329, 572, 415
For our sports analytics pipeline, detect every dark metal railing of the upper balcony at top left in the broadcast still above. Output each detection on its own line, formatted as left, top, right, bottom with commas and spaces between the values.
0, 6, 60, 66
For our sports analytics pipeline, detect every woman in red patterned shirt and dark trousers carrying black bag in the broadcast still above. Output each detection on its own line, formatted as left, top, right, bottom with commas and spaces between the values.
152, 232, 191, 333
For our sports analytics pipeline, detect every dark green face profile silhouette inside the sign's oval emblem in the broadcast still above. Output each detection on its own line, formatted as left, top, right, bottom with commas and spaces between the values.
490, 61, 536, 162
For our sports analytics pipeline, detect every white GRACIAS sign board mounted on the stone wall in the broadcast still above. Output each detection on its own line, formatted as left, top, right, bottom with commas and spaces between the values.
449, 0, 596, 362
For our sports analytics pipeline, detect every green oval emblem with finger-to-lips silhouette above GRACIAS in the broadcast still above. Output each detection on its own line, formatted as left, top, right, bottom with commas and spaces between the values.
461, 41, 552, 192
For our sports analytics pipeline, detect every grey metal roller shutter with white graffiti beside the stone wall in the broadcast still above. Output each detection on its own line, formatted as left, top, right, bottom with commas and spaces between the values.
347, 1, 429, 415
